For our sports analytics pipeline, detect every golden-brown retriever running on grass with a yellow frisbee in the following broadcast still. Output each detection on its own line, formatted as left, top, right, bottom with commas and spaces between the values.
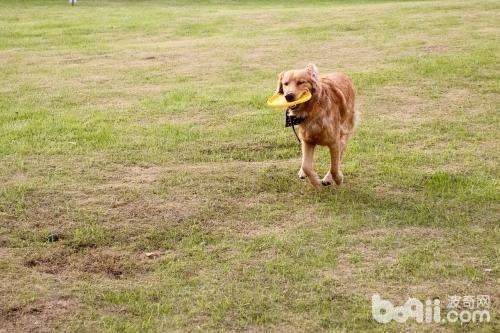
276, 64, 358, 188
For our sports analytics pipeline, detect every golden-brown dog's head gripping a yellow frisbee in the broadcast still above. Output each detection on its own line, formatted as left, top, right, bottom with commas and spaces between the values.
276, 64, 318, 111
